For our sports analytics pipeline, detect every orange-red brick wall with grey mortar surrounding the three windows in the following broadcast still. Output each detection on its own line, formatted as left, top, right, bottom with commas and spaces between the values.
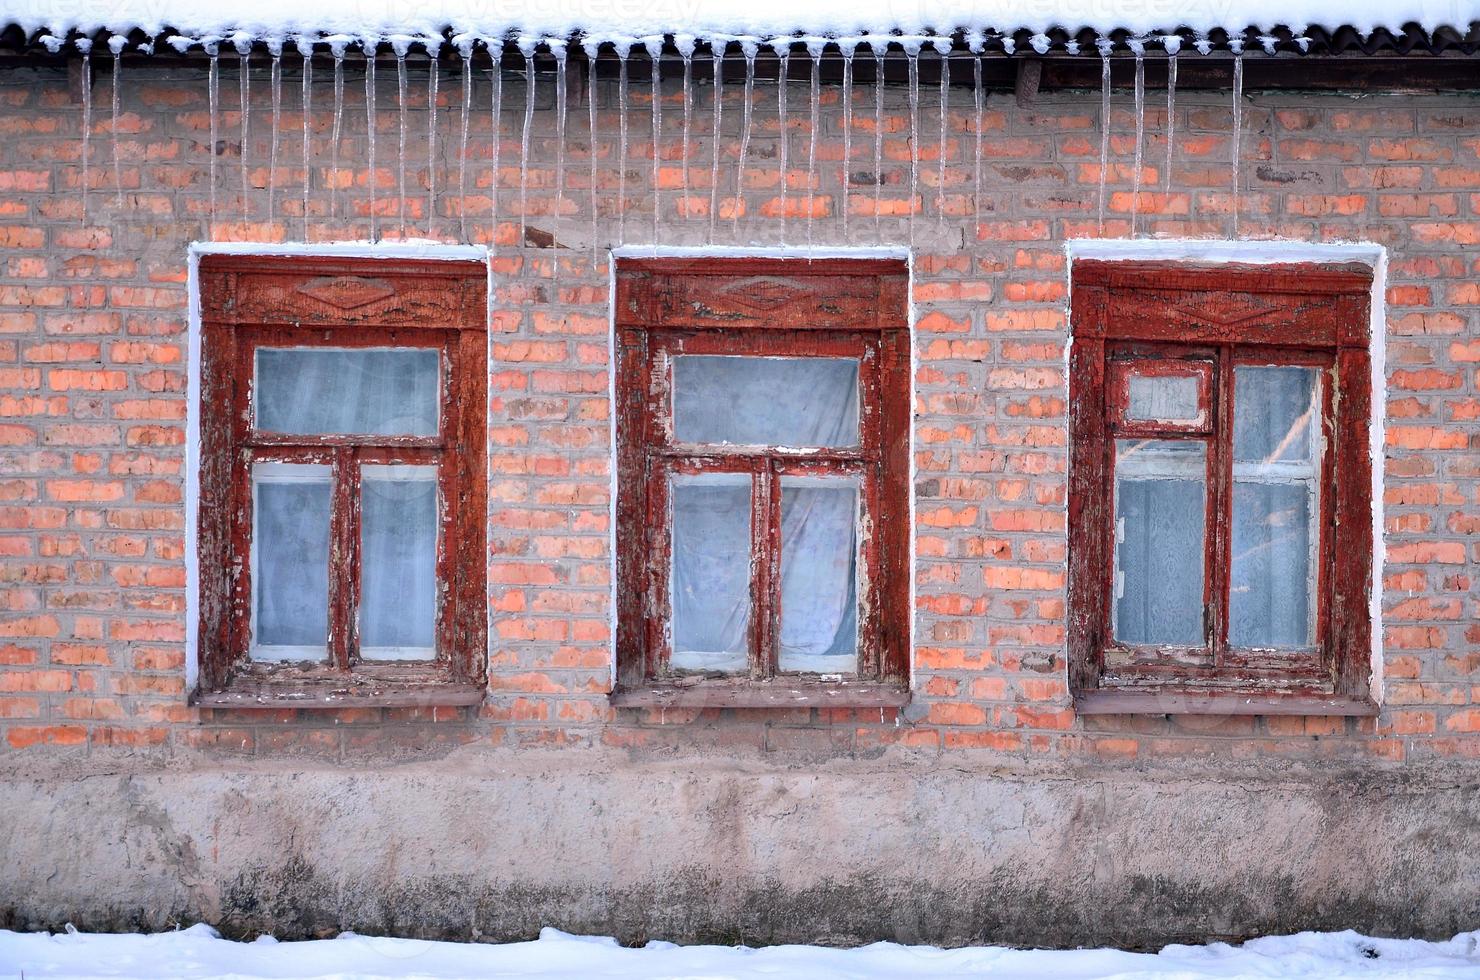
0, 61, 1480, 764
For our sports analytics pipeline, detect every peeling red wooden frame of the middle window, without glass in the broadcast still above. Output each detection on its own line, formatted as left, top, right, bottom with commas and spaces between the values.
611, 259, 910, 708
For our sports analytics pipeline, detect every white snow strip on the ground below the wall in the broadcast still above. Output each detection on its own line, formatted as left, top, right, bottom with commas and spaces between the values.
0, 925, 1480, 980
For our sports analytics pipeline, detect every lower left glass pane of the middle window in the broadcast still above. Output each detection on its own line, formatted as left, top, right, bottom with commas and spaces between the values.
669, 474, 750, 674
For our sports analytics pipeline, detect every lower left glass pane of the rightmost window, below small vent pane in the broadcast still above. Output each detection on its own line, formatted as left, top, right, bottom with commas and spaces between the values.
1113, 440, 1208, 647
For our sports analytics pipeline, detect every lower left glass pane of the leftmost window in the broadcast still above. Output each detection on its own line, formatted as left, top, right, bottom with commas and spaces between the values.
252, 463, 330, 660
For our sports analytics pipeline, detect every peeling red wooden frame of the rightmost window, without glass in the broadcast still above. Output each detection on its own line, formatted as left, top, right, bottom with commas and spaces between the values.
1069, 259, 1378, 715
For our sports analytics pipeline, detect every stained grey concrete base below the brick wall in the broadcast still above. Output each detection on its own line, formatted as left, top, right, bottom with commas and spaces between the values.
0, 748, 1480, 947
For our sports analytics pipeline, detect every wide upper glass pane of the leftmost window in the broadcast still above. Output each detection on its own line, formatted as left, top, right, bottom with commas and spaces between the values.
253, 348, 440, 435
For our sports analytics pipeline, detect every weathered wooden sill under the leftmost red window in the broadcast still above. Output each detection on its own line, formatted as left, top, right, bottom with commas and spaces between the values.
191, 665, 484, 711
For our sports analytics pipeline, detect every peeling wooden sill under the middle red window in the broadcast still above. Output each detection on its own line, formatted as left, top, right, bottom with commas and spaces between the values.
610, 678, 910, 708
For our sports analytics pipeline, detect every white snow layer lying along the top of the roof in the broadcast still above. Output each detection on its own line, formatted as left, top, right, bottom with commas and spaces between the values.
0, 0, 1480, 43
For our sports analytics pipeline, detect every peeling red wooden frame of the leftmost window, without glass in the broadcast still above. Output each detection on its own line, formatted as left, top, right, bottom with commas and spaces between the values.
191, 255, 487, 708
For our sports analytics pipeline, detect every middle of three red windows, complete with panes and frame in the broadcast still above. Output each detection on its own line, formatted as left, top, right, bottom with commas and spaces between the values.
613, 259, 910, 706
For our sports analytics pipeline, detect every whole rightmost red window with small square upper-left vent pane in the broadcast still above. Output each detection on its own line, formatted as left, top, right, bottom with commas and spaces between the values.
1069, 261, 1375, 715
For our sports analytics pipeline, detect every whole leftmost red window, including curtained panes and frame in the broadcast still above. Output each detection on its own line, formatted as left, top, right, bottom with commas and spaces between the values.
197, 256, 487, 708
